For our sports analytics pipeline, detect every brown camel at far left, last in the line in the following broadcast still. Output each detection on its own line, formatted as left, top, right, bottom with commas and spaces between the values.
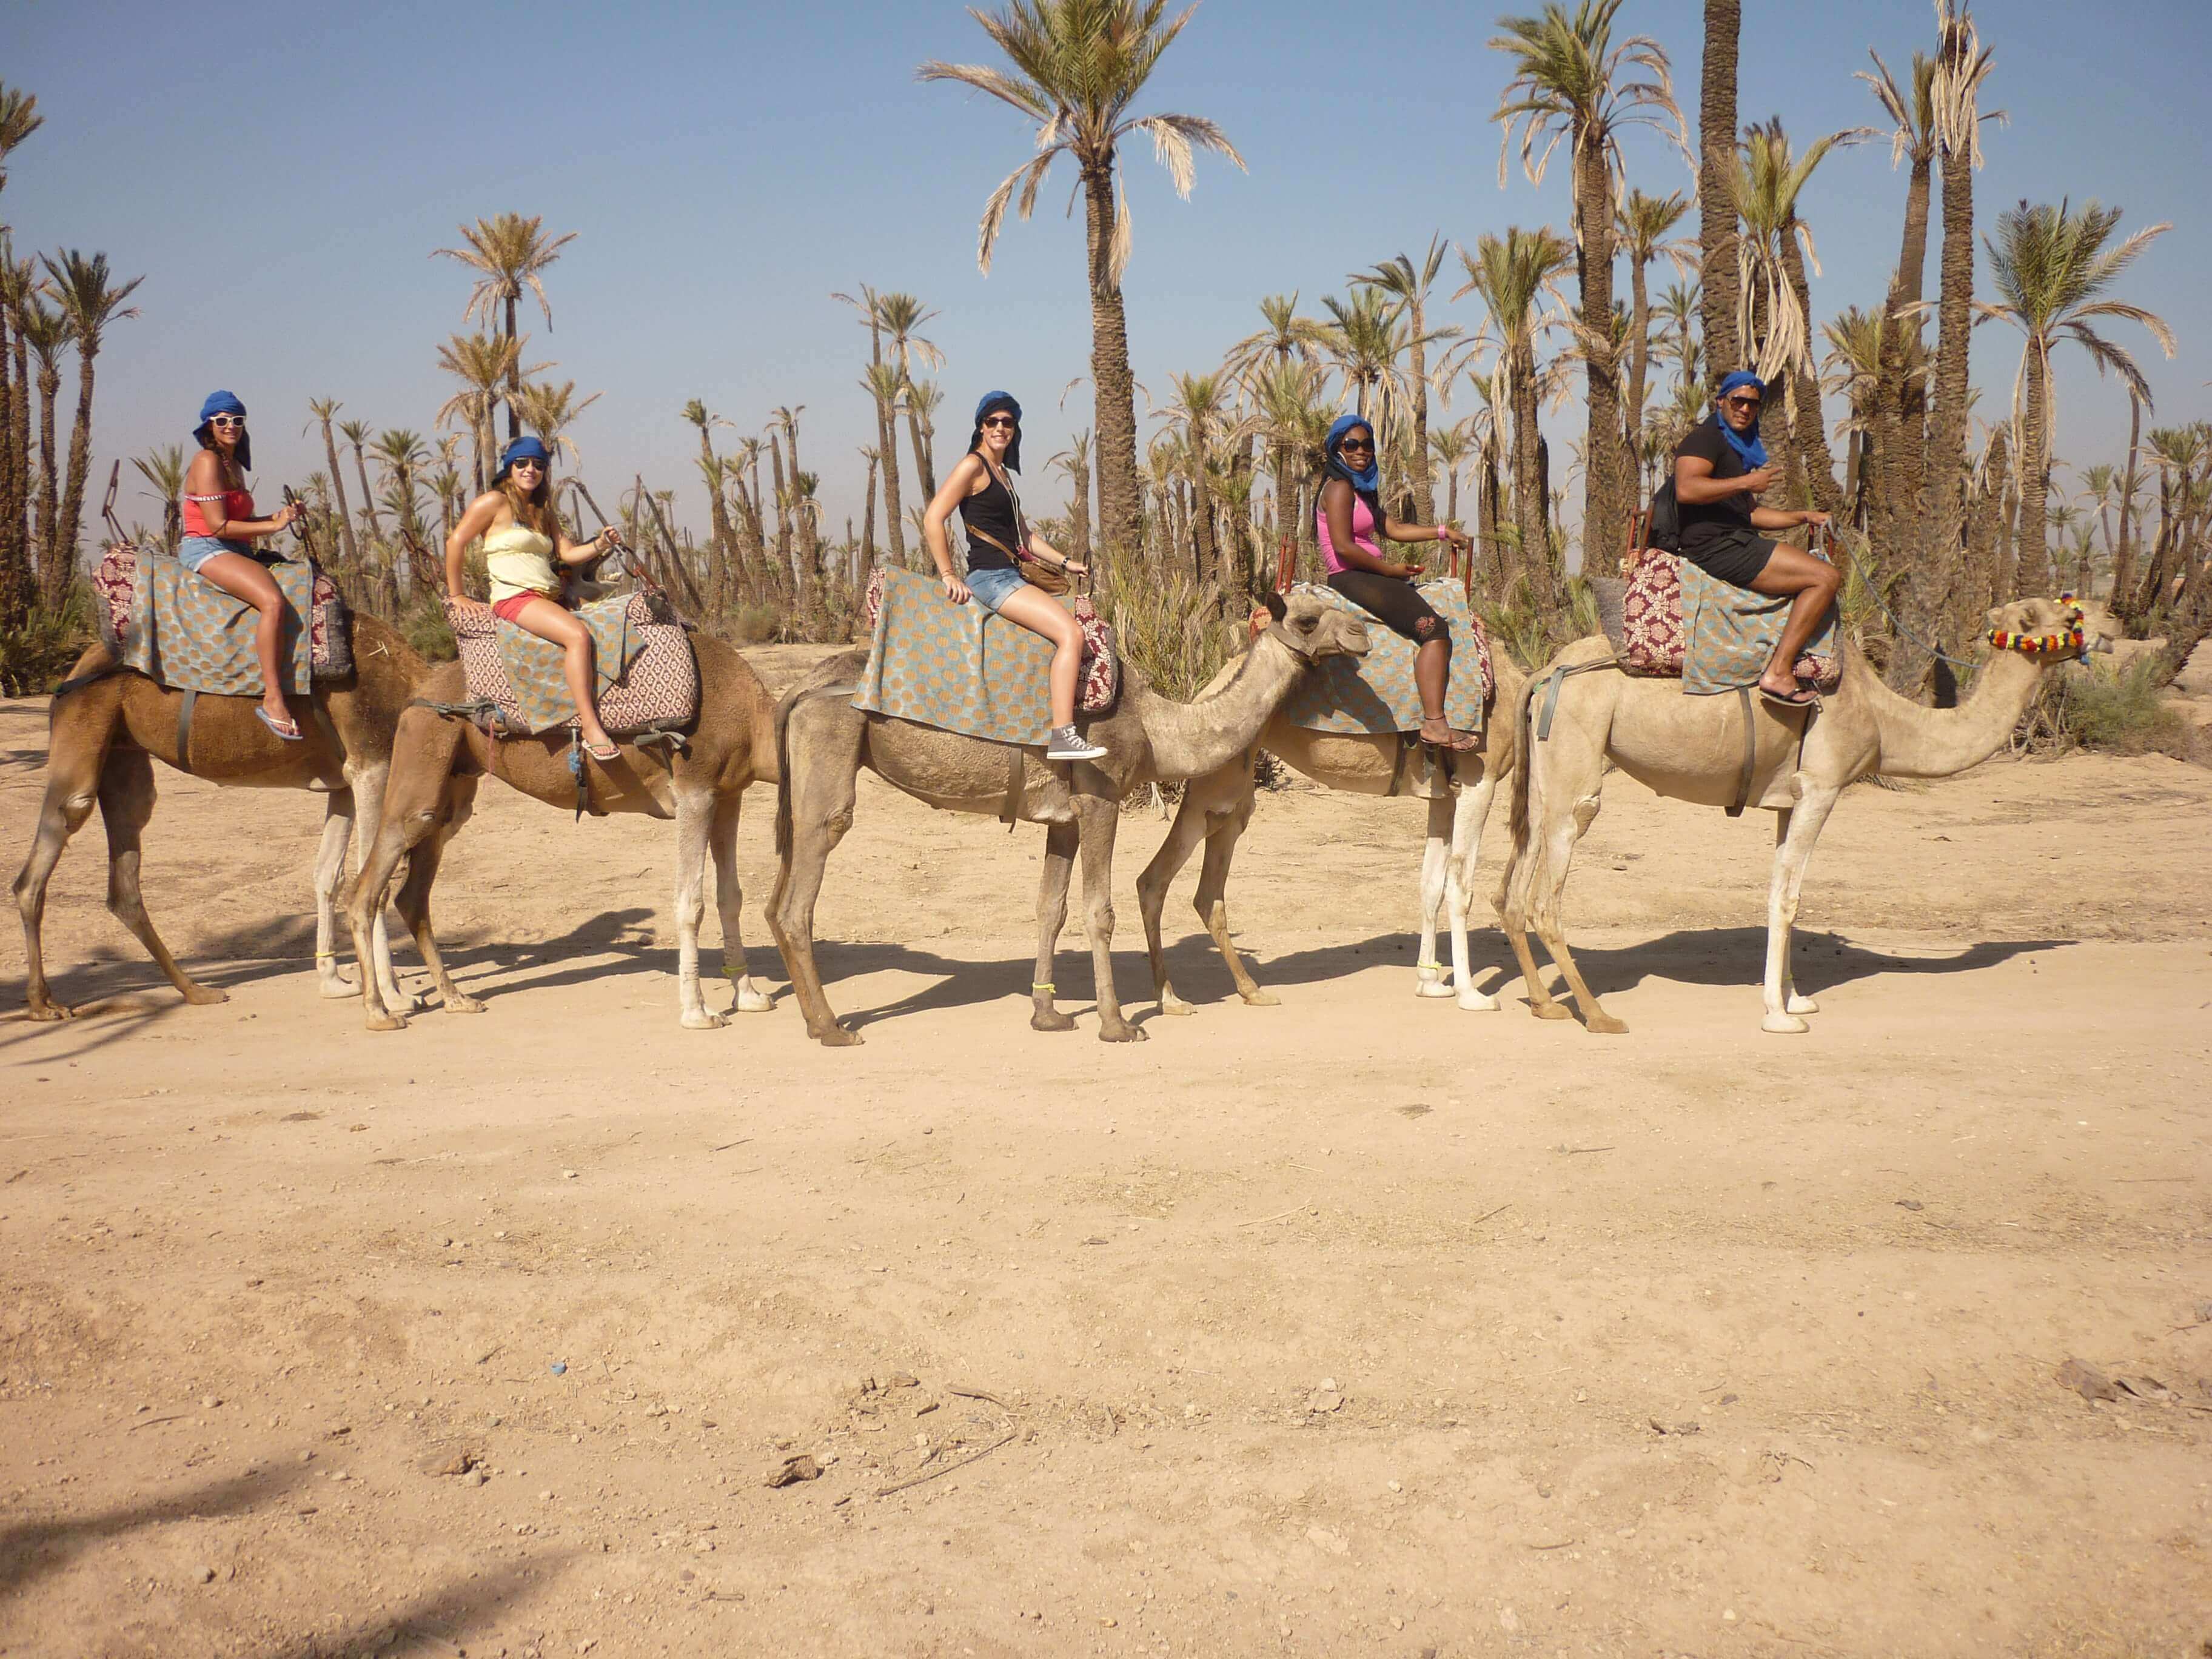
16, 612, 429, 1020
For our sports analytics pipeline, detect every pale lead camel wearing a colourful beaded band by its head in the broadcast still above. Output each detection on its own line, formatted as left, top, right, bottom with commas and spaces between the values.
1500, 600, 2114, 1033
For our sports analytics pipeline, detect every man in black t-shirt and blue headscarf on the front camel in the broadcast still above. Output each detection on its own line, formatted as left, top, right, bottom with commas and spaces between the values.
1675, 369, 1843, 708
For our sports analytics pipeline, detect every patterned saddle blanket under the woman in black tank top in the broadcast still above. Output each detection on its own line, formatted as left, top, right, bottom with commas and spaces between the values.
851, 564, 1122, 745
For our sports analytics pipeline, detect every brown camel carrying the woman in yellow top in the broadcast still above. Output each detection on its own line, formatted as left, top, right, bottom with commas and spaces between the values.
347, 632, 776, 1031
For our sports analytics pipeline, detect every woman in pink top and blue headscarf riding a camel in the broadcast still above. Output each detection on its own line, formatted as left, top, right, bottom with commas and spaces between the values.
1314, 416, 1482, 750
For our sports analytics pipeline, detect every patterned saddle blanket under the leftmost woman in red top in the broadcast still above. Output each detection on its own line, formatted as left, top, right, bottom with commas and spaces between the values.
93, 542, 354, 697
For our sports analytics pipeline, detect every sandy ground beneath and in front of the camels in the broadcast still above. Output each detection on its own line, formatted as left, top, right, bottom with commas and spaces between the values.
0, 652, 2212, 1659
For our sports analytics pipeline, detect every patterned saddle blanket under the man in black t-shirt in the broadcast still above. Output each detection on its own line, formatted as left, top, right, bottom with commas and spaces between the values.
1590, 546, 1843, 697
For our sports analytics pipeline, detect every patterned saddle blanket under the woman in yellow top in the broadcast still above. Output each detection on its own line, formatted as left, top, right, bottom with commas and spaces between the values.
460, 593, 699, 737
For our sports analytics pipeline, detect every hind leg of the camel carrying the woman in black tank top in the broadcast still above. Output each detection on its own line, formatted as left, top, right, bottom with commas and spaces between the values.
768, 699, 867, 1048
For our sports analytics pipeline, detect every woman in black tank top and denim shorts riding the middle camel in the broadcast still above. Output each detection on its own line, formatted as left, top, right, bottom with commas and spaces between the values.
922, 392, 1106, 761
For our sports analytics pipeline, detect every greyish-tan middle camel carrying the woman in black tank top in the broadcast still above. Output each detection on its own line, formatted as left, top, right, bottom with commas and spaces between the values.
768, 595, 1367, 1048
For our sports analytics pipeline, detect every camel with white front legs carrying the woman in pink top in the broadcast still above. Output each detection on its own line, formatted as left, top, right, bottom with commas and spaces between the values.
1137, 644, 1522, 1013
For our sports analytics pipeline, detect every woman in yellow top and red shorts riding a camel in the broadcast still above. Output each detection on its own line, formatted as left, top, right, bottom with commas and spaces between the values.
444, 438, 622, 761
